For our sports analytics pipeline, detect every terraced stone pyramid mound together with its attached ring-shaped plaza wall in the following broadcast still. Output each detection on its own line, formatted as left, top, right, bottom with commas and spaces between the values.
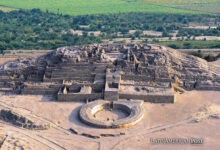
0, 44, 220, 128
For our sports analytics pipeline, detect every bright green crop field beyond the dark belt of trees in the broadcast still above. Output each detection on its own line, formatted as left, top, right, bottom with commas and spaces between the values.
0, 0, 220, 15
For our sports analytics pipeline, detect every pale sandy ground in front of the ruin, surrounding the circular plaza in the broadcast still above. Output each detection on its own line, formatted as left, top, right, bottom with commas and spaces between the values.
0, 91, 220, 150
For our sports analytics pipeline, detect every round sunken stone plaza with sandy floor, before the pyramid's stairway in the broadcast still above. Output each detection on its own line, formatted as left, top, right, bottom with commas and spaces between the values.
79, 100, 144, 128
